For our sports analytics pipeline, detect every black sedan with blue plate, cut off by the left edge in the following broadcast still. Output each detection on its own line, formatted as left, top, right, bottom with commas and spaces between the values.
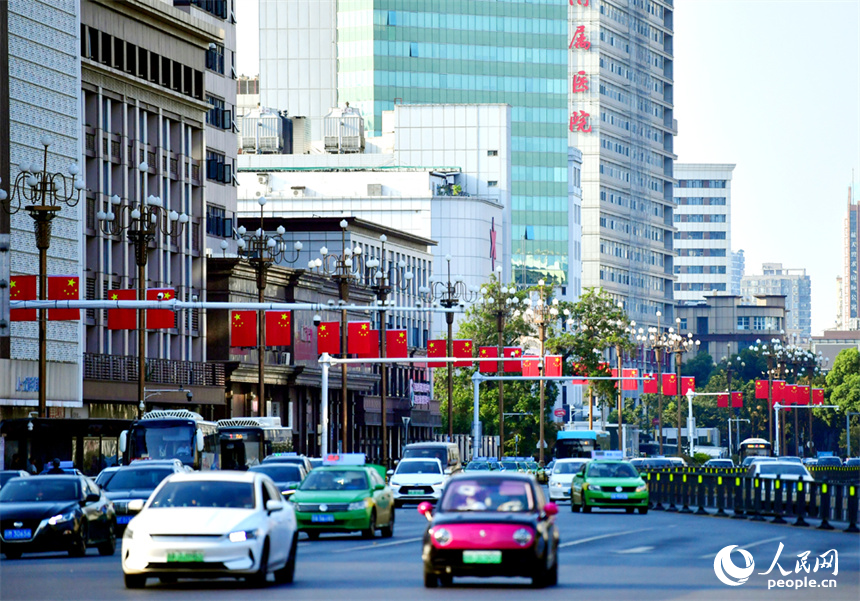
0, 476, 116, 559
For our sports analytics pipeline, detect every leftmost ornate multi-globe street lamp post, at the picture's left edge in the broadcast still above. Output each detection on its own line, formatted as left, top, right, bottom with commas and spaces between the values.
0, 135, 86, 417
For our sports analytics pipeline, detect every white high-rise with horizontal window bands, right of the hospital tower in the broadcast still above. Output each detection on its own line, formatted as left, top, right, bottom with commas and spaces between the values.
674, 163, 740, 302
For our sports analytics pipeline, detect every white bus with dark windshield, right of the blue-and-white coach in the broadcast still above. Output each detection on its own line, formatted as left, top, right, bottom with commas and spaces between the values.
218, 417, 293, 470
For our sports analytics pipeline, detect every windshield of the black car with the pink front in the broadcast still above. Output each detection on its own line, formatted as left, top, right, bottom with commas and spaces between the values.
442, 478, 535, 512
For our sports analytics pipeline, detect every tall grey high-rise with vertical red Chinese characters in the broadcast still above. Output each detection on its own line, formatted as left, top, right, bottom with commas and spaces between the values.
568, 0, 677, 324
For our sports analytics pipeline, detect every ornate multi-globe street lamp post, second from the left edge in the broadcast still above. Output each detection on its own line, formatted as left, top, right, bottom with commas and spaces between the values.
96, 162, 188, 417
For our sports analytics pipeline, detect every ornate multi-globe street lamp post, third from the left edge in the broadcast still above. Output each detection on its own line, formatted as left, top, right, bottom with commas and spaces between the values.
228, 196, 302, 417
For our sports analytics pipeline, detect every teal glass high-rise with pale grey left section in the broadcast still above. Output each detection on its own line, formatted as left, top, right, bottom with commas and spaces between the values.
260, 0, 576, 287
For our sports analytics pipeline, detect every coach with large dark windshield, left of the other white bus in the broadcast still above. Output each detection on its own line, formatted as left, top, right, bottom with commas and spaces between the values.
119, 409, 218, 470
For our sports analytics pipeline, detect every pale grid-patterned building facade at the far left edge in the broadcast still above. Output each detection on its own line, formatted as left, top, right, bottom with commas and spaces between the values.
0, 0, 85, 420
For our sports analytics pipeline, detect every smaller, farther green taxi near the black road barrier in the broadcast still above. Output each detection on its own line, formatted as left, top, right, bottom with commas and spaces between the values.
570, 459, 648, 514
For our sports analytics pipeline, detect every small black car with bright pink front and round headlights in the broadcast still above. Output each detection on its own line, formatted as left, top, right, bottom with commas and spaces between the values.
418, 472, 559, 588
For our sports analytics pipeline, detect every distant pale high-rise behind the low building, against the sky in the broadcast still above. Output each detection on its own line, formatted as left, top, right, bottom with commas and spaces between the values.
741, 263, 812, 342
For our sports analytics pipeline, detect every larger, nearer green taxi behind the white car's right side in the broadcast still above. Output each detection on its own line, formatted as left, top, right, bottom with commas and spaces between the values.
290, 453, 394, 539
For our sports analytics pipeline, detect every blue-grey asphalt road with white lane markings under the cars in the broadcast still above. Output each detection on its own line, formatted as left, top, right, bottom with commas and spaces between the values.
0, 504, 860, 601
